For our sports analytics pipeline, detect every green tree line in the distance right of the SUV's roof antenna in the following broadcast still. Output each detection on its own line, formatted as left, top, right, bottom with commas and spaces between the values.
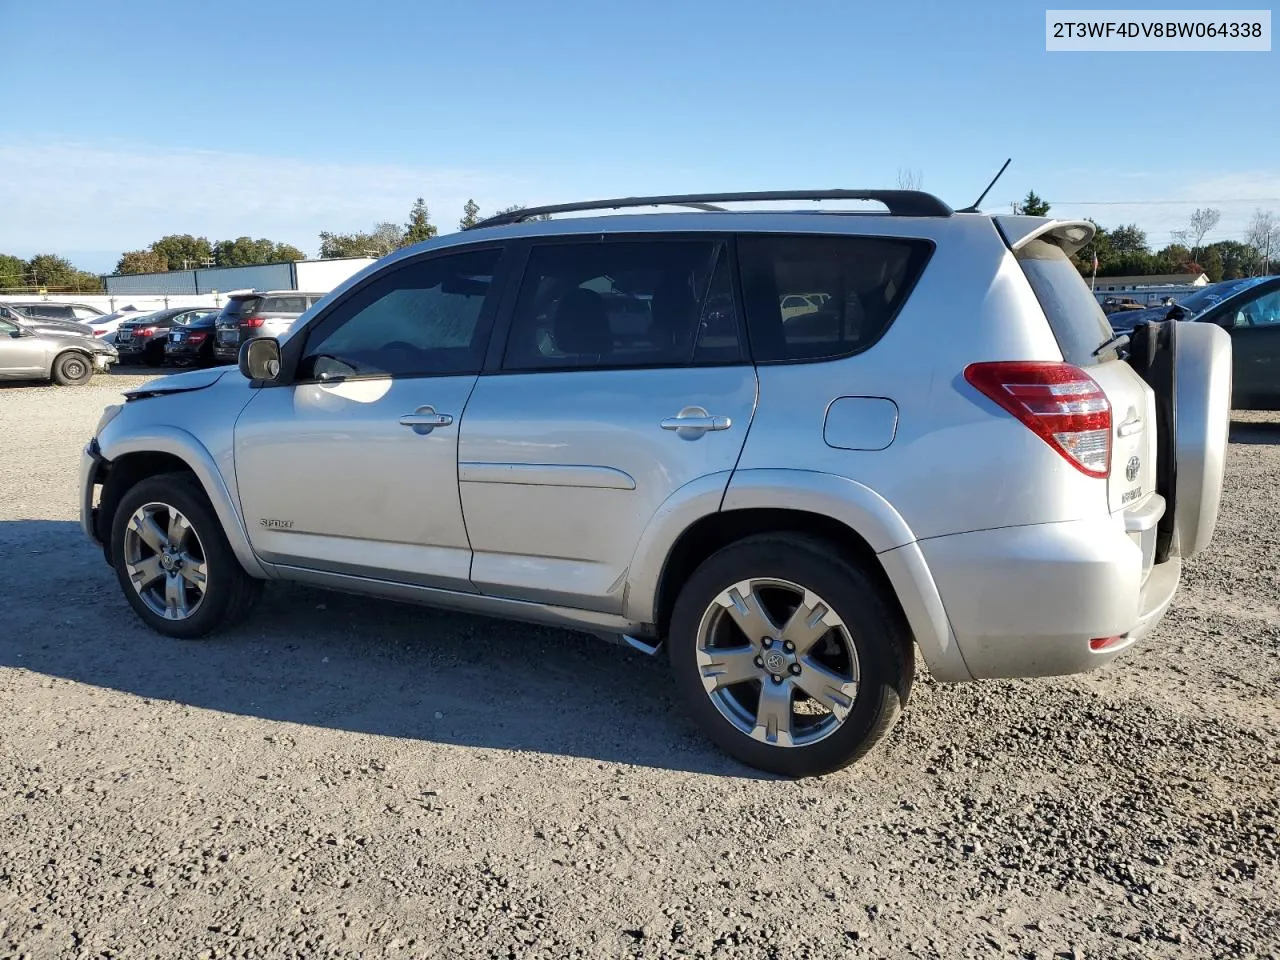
1014, 191, 1280, 283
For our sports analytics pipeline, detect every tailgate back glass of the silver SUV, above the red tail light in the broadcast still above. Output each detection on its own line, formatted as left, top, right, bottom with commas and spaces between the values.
1018, 239, 1111, 366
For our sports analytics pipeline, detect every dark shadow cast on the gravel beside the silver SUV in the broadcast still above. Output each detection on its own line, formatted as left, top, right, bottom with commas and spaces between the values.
0, 520, 769, 780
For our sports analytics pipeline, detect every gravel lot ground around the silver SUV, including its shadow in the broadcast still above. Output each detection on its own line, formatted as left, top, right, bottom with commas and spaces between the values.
0, 371, 1280, 959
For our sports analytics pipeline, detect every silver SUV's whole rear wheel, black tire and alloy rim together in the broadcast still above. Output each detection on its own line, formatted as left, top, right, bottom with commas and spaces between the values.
668, 536, 911, 777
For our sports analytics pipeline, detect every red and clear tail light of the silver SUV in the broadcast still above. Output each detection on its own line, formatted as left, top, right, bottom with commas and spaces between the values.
964, 360, 1111, 477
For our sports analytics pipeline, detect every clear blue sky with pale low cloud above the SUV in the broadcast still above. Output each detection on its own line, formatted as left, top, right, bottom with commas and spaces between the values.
0, 0, 1280, 270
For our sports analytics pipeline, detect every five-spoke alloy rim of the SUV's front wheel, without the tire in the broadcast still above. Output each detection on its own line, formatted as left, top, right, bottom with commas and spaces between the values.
124, 502, 209, 620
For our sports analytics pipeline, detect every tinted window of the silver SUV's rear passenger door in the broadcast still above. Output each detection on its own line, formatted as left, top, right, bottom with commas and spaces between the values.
503, 241, 742, 370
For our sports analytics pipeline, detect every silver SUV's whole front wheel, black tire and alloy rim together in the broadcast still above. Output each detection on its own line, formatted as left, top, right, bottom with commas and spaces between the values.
110, 474, 261, 639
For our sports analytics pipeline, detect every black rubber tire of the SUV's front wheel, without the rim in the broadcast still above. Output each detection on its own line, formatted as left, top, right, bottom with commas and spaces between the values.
110, 472, 262, 640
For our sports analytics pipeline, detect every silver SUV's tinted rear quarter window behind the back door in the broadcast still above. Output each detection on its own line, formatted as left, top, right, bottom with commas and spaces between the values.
737, 234, 933, 364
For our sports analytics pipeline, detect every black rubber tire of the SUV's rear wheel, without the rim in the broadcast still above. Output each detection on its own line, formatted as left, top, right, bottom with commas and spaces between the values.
667, 534, 914, 777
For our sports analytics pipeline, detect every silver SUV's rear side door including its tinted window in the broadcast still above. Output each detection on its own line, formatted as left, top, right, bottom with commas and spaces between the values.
458, 236, 756, 613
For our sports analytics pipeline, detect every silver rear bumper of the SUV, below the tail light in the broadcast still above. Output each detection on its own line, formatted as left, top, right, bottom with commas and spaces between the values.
920, 511, 1181, 678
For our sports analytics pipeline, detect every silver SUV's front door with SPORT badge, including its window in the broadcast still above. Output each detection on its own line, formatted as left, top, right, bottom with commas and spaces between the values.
236, 247, 502, 590
